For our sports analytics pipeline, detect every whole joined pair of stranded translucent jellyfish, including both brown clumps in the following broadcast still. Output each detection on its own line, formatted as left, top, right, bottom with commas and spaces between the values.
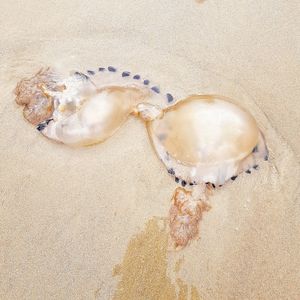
15, 66, 268, 248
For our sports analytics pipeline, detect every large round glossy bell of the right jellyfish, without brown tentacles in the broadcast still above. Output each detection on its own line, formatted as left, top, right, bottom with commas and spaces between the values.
147, 95, 267, 186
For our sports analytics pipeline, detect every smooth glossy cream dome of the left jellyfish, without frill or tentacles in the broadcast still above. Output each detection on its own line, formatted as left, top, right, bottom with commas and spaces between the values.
42, 87, 150, 146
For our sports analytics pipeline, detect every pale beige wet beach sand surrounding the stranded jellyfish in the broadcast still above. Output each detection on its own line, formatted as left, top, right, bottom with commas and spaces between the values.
0, 0, 300, 300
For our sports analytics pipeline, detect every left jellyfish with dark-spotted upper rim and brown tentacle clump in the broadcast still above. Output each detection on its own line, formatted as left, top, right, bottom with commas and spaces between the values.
15, 67, 159, 146
